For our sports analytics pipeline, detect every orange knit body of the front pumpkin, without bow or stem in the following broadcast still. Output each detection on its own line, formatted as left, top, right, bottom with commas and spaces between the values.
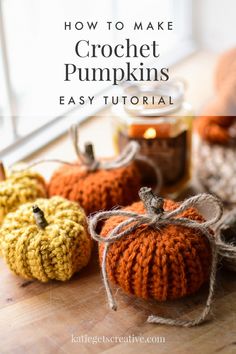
99, 201, 211, 301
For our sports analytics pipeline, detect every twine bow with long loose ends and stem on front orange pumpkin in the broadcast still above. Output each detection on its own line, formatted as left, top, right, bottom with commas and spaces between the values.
89, 187, 223, 327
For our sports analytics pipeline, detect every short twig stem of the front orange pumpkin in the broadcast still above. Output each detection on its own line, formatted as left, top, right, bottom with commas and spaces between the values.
139, 187, 164, 214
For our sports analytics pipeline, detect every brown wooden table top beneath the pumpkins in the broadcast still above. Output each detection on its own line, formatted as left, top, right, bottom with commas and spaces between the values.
0, 52, 236, 354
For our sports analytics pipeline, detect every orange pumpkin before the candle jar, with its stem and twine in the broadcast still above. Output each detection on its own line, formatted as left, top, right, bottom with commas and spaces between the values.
48, 126, 159, 215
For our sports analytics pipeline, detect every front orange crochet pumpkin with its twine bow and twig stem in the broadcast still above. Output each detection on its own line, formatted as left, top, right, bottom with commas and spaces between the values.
89, 187, 223, 327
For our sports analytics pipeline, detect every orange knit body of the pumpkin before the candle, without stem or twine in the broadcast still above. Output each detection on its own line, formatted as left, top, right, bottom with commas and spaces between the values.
48, 162, 141, 215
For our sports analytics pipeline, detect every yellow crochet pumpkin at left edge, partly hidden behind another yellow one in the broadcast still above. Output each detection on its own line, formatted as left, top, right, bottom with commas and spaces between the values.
0, 170, 47, 223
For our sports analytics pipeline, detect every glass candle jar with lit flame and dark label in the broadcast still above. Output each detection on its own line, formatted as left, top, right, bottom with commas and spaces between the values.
112, 81, 193, 197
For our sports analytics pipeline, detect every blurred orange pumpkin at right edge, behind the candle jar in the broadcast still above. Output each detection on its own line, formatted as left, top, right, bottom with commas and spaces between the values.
196, 48, 236, 144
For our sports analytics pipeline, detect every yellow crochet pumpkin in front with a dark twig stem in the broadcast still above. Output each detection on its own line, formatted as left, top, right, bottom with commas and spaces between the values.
0, 197, 92, 282
